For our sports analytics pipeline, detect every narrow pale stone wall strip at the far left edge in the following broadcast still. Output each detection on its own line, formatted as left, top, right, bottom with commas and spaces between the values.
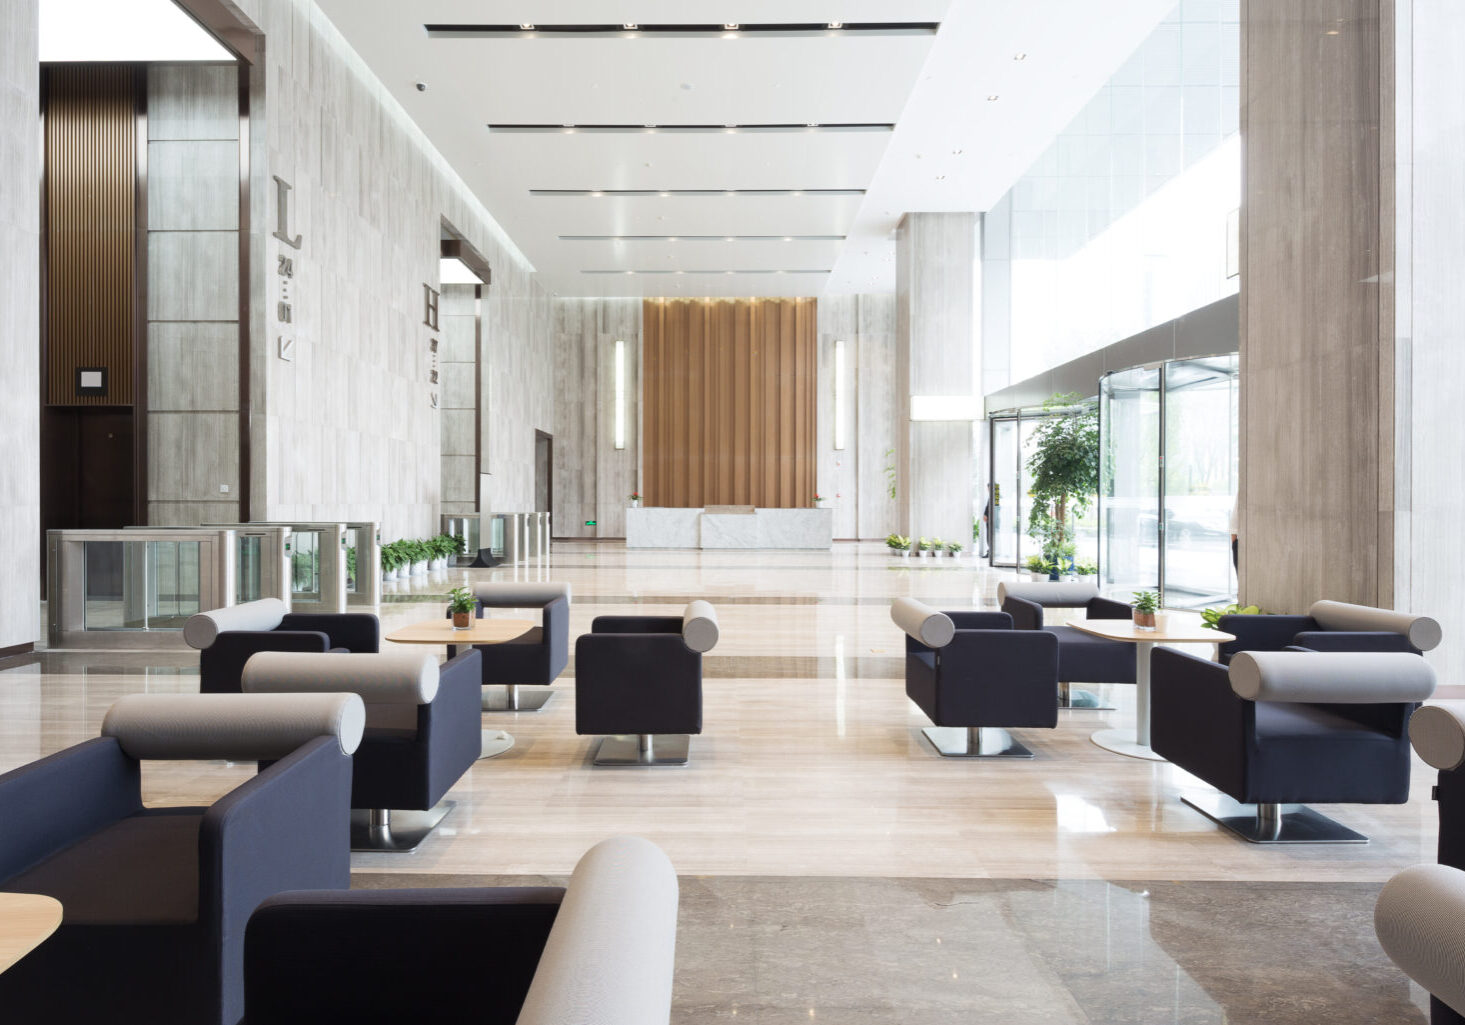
0, 0, 41, 650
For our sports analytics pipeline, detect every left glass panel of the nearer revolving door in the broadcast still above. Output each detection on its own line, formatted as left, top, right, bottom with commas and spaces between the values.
1099, 368, 1160, 597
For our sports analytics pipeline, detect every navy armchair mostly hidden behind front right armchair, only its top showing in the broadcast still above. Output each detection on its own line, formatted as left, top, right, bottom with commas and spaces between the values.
1216, 602, 1443, 663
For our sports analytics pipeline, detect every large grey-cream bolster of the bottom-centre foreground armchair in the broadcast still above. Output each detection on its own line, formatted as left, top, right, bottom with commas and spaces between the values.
516, 836, 677, 1025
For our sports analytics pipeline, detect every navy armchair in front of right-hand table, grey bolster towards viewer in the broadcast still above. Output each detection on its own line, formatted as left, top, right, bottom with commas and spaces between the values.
1150, 647, 1434, 843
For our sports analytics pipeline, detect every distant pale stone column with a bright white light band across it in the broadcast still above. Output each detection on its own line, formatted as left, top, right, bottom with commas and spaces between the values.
895, 214, 980, 545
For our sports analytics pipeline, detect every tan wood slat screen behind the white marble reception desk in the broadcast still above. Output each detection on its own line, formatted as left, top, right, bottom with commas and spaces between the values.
642, 299, 817, 508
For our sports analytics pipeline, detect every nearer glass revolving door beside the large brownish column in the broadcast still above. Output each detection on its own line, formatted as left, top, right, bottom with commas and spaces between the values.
1099, 354, 1238, 608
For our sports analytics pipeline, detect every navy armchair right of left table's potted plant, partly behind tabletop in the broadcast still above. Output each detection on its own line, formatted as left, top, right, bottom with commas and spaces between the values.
460, 580, 570, 712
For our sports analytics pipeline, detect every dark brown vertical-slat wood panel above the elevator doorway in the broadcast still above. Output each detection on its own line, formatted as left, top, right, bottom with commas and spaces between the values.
45, 64, 141, 406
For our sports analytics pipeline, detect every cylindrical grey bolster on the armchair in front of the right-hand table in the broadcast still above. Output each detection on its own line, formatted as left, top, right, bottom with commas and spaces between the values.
1231, 652, 1434, 704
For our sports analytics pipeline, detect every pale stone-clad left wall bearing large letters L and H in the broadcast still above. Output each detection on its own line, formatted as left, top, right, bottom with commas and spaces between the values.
239, 0, 554, 539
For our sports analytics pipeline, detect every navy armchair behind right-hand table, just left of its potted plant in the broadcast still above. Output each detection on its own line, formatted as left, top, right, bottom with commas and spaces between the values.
998, 581, 1135, 709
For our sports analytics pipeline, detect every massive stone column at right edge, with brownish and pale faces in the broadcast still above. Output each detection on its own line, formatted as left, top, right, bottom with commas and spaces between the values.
1239, 0, 1465, 685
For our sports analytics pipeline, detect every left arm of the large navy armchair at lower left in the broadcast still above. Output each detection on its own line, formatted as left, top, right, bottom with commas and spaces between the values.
0, 737, 142, 880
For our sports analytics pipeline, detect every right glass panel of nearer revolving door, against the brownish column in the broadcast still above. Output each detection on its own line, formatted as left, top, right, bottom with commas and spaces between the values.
1162, 356, 1239, 608
